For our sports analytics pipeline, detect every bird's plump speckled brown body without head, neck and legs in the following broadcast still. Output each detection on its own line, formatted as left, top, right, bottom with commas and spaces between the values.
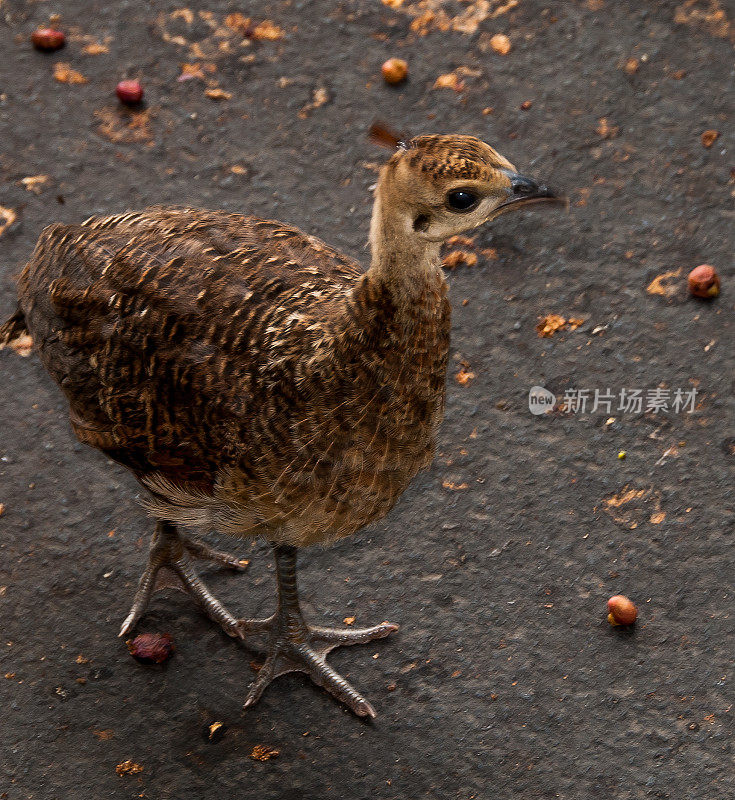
19, 207, 449, 543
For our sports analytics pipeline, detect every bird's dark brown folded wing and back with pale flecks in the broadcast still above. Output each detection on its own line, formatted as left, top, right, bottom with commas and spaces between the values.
20, 207, 362, 490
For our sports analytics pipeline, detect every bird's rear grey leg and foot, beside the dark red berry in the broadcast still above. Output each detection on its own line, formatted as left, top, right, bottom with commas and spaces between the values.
120, 521, 247, 636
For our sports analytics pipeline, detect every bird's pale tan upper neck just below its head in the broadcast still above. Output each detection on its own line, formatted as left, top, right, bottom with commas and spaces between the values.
368, 191, 445, 306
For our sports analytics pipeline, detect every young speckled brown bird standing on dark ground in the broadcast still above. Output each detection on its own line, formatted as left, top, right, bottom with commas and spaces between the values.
0, 135, 559, 717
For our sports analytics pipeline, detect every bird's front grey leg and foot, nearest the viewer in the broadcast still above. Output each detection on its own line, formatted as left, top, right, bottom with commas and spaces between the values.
239, 545, 398, 717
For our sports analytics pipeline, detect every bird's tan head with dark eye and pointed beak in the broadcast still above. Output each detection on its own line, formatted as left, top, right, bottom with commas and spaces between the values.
370, 135, 567, 242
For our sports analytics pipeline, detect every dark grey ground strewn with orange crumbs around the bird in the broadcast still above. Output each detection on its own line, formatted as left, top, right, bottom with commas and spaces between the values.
0, 0, 735, 800
